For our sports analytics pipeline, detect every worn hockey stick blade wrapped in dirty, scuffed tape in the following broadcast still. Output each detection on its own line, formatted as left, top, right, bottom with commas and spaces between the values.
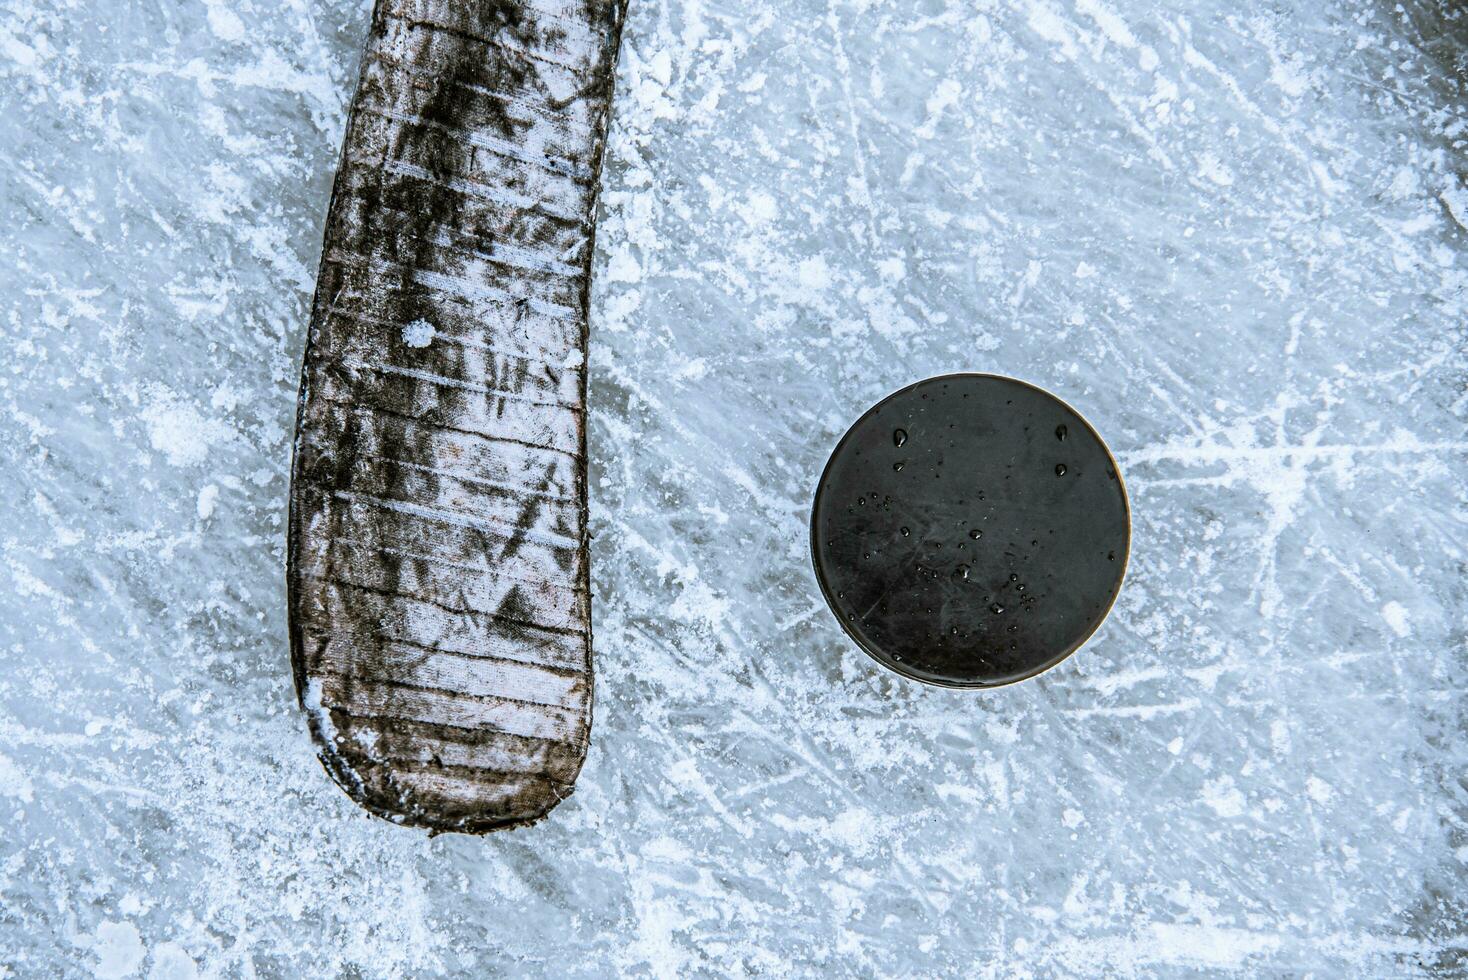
286, 0, 625, 833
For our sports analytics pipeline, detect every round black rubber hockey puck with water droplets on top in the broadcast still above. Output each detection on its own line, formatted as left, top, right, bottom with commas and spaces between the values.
810, 374, 1132, 688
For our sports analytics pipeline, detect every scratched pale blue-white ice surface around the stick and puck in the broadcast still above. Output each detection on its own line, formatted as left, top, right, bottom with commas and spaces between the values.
0, 0, 1468, 979
